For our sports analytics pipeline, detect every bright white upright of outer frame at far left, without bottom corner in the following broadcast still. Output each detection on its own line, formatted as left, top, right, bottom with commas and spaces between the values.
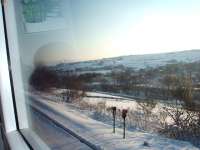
0, 1, 17, 132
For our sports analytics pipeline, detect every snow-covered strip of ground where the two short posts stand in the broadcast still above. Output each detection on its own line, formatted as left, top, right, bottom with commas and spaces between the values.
28, 92, 198, 150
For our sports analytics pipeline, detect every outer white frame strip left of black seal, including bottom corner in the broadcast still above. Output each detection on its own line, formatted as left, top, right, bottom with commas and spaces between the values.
0, 1, 29, 150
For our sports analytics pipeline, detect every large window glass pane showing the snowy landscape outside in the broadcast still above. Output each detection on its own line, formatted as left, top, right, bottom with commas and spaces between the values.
8, 0, 200, 150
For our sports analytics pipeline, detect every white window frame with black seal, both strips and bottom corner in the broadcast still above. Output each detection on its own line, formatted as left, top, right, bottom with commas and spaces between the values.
0, 0, 48, 150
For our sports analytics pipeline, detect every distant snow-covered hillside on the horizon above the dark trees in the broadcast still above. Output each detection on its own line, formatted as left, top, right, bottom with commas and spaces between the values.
55, 50, 200, 72
